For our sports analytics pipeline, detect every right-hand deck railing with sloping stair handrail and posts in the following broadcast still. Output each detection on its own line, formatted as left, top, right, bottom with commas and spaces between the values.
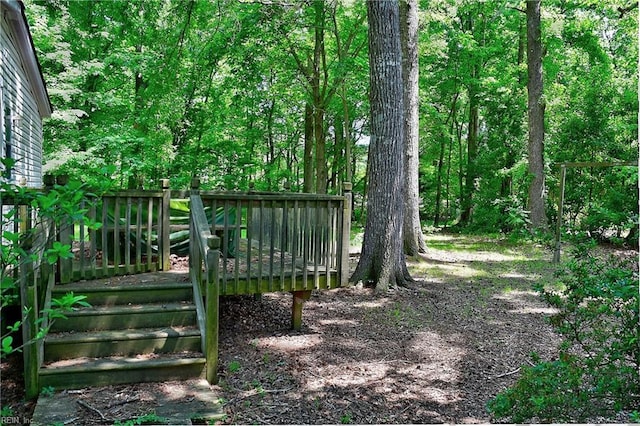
189, 180, 351, 383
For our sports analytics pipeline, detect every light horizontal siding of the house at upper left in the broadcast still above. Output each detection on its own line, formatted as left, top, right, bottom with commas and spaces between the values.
0, 1, 43, 187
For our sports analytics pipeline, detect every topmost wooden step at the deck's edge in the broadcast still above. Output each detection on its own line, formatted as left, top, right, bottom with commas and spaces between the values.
52, 281, 193, 306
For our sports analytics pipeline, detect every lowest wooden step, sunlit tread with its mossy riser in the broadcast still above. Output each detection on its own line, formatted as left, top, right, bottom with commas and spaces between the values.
40, 354, 205, 390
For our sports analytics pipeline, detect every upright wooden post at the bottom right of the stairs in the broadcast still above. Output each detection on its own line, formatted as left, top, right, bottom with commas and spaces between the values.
205, 235, 220, 385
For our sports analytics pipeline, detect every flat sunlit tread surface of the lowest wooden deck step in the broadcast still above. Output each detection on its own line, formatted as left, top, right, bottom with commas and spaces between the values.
40, 352, 206, 375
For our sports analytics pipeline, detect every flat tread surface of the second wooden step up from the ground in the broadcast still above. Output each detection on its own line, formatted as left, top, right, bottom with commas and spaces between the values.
45, 326, 200, 344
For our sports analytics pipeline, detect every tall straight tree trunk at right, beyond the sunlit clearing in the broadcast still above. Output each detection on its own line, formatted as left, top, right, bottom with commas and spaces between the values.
527, 0, 547, 230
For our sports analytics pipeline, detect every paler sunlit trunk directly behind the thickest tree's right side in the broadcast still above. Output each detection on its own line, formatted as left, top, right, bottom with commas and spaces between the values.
400, 0, 427, 256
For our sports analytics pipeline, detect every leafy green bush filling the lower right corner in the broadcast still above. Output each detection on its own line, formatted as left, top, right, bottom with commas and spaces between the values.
488, 241, 640, 423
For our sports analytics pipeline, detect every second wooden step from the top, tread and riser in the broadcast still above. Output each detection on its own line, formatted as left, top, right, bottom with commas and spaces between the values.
51, 303, 197, 332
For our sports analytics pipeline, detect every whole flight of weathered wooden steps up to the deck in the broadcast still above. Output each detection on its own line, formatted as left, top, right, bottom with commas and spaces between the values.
40, 281, 205, 389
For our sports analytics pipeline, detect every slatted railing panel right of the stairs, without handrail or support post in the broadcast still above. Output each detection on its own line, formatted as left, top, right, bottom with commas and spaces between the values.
199, 186, 350, 294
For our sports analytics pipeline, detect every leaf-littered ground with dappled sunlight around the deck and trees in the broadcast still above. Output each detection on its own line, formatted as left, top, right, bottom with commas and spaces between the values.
1, 234, 637, 425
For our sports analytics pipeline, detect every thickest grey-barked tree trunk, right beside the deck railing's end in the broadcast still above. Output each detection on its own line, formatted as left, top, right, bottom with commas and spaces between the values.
351, 0, 411, 291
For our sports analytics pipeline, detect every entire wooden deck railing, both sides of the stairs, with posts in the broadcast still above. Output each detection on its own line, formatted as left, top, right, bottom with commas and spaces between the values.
6, 180, 351, 392
